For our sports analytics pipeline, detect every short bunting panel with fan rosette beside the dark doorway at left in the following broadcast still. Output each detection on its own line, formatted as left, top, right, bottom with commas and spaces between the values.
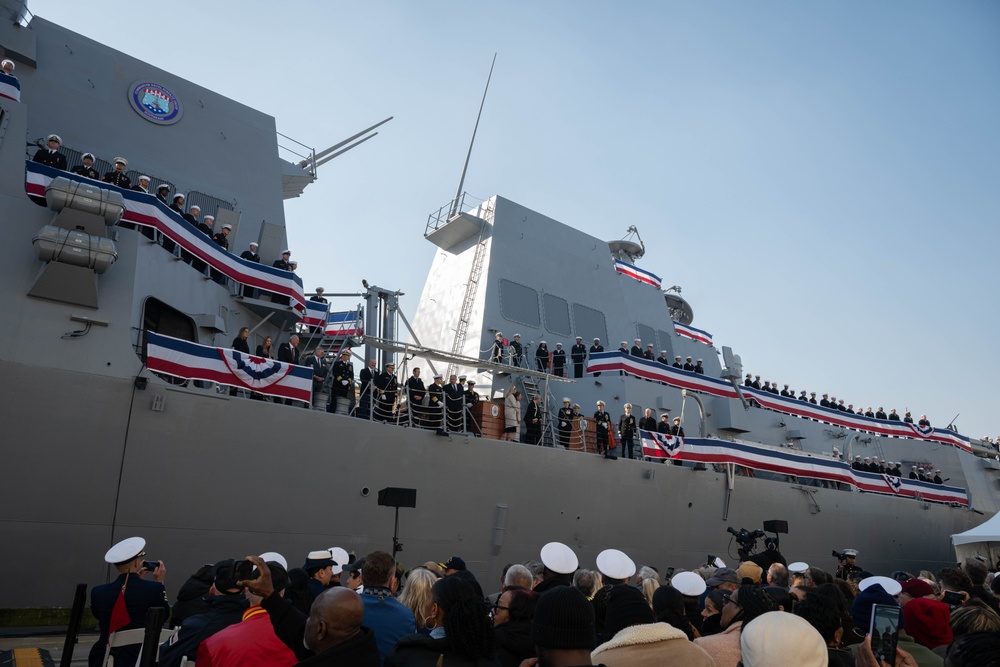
146, 331, 312, 403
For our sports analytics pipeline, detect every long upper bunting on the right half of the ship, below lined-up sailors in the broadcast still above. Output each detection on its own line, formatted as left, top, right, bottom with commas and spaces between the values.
587, 351, 972, 452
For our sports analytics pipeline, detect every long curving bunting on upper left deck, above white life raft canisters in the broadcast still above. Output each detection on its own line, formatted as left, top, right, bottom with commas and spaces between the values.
24, 162, 306, 313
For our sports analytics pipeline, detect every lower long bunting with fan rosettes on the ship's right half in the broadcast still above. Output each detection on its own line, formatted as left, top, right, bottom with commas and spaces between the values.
639, 430, 969, 507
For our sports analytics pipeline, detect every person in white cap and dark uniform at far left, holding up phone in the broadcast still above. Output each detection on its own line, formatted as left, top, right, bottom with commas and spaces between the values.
90, 537, 170, 665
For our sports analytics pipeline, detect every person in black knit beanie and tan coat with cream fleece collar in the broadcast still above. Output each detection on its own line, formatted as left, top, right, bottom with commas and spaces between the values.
590, 585, 715, 667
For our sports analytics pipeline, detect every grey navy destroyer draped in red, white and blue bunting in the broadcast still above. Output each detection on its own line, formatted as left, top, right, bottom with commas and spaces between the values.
0, 3, 1000, 607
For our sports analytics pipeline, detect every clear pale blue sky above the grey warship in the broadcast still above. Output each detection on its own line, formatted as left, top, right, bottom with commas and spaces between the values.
39, 0, 1000, 436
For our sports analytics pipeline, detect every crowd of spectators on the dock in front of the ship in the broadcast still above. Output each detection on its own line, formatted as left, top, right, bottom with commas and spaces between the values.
91, 538, 1000, 667
